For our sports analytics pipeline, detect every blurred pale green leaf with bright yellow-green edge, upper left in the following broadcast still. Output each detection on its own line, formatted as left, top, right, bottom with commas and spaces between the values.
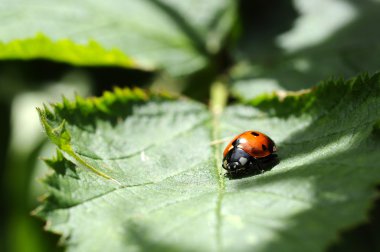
0, 0, 235, 74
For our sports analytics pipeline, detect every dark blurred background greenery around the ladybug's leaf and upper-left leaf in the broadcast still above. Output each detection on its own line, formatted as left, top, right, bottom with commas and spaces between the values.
0, 0, 380, 251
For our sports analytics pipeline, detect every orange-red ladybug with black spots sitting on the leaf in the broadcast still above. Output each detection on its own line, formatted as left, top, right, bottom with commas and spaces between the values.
222, 130, 277, 176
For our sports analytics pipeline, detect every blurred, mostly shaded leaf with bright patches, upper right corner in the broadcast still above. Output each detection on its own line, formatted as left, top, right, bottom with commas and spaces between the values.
232, 0, 380, 99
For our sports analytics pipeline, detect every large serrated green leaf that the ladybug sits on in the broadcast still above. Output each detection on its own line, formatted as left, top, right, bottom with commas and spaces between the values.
36, 74, 380, 251
